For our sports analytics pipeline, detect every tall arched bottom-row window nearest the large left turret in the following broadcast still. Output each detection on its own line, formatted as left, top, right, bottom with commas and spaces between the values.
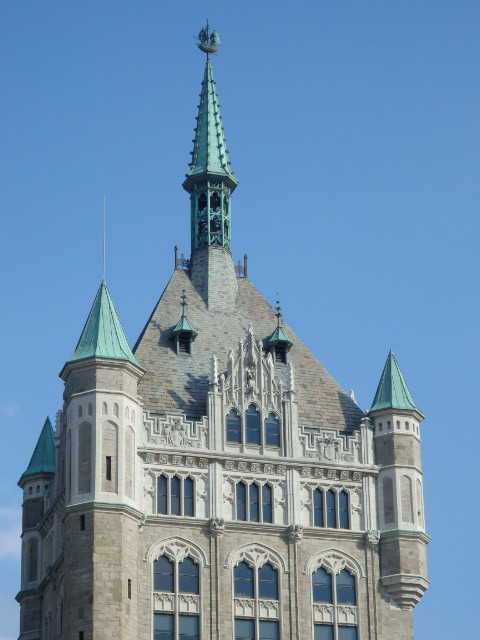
153, 555, 200, 640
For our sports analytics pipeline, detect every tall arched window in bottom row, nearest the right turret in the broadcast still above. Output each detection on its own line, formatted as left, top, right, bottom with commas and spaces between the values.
312, 567, 358, 640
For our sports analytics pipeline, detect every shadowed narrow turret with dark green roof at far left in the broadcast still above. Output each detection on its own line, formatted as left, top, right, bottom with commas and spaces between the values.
17, 418, 55, 640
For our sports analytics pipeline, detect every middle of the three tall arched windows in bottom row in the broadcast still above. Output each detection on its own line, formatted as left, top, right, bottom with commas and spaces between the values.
233, 561, 280, 640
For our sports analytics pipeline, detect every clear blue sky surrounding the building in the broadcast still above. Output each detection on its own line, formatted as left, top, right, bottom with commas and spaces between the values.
0, 0, 480, 640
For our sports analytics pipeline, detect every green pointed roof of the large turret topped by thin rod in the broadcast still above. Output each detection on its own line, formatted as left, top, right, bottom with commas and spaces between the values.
67, 281, 143, 369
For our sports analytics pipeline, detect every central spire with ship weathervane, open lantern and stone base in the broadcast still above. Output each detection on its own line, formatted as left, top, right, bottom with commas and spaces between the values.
183, 27, 238, 311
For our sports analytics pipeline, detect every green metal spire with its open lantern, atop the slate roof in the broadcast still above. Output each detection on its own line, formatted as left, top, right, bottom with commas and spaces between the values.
183, 57, 238, 251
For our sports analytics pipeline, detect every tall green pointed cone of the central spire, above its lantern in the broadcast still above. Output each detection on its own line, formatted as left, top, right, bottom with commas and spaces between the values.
183, 58, 238, 191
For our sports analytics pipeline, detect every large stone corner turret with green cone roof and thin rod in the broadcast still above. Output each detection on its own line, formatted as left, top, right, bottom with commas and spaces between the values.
60, 282, 144, 640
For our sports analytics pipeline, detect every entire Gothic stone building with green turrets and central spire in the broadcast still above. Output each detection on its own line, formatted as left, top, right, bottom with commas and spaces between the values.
17, 32, 429, 640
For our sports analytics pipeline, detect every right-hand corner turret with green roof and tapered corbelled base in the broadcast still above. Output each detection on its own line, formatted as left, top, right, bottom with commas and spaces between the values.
370, 351, 429, 609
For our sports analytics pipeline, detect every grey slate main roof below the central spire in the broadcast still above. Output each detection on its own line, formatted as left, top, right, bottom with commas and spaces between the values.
133, 270, 363, 430
